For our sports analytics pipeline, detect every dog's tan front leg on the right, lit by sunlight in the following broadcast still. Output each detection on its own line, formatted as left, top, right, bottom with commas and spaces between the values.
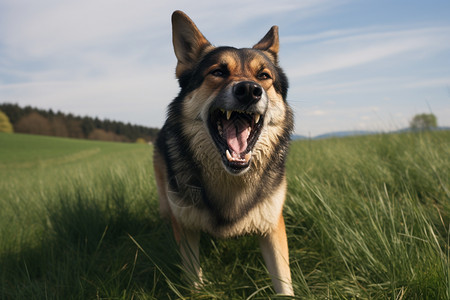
259, 215, 294, 295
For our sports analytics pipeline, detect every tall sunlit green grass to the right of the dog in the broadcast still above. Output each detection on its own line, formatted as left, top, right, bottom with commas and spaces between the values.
287, 132, 450, 299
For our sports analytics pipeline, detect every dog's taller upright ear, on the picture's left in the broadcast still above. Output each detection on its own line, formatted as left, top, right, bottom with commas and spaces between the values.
172, 10, 211, 78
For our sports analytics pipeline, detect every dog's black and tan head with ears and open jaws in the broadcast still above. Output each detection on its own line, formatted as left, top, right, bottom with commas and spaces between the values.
172, 11, 290, 175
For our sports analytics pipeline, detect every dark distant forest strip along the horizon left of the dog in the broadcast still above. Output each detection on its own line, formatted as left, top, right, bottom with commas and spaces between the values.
0, 103, 159, 142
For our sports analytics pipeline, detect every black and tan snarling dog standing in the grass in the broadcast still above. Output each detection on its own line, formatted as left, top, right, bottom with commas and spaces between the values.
153, 11, 294, 295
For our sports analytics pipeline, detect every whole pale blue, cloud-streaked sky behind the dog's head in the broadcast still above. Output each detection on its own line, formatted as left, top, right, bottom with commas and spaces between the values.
0, 0, 450, 137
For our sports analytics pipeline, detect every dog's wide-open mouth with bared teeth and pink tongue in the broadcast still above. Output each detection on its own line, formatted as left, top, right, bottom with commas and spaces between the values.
209, 109, 264, 173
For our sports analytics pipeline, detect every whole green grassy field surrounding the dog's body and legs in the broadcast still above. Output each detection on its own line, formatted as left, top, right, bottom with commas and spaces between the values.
0, 131, 450, 299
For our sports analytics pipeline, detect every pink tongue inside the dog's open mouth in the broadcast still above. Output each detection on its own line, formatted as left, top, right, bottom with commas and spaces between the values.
223, 120, 250, 155
